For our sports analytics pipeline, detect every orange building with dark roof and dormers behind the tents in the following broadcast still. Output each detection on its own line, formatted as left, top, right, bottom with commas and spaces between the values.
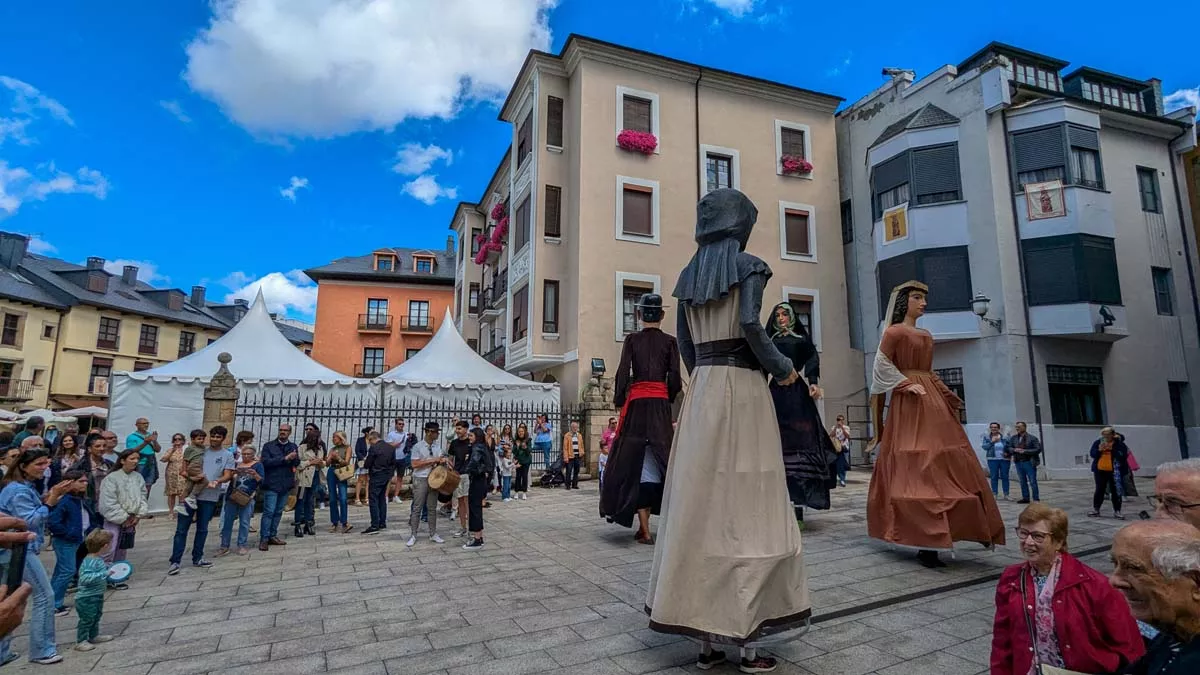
305, 238, 455, 377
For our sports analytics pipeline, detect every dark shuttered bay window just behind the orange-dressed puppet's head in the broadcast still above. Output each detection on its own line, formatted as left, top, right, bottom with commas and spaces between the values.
877, 246, 971, 319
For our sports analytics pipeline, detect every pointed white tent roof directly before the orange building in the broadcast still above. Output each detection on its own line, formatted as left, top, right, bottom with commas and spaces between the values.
379, 310, 559, 406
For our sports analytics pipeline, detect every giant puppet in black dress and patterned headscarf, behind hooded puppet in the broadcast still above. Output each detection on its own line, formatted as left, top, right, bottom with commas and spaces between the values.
766, 303, 838, 528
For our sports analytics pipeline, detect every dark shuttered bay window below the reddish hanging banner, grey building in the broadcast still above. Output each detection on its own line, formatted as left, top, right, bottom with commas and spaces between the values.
1021, 234, 1121, 306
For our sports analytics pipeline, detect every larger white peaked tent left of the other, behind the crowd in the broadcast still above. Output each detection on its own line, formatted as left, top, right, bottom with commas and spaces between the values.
108, 292, 379, 510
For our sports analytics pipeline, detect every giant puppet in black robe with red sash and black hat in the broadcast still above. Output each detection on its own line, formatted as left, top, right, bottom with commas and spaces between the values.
600, 293, 683, 544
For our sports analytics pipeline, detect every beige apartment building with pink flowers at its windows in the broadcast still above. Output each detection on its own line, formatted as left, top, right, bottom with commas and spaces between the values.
451, 35, 865, 412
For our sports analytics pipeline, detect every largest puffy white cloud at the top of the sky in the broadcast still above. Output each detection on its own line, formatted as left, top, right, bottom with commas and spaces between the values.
184, 0, 556, 138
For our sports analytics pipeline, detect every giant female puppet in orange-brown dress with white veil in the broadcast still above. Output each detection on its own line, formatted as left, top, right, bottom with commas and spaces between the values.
866, 281, 1004, 567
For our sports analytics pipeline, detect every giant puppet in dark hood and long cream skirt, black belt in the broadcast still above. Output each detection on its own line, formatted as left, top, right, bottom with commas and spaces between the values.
646, 189, 811, 673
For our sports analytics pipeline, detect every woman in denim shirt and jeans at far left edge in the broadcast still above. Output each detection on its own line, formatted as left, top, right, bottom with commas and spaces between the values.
0, 448, 72, 665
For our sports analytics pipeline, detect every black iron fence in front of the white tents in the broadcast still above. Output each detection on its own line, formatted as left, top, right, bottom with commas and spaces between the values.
234, 392, 583, 471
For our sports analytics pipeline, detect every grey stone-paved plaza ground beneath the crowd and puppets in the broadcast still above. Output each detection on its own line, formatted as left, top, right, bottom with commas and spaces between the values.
5, 472, 1141, 675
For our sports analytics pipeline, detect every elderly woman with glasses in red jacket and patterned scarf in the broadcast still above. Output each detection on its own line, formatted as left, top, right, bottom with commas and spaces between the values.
991, 503, 1146, 675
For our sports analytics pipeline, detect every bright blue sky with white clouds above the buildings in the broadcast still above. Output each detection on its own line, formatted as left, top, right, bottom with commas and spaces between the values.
0, 0, 1200, 318
